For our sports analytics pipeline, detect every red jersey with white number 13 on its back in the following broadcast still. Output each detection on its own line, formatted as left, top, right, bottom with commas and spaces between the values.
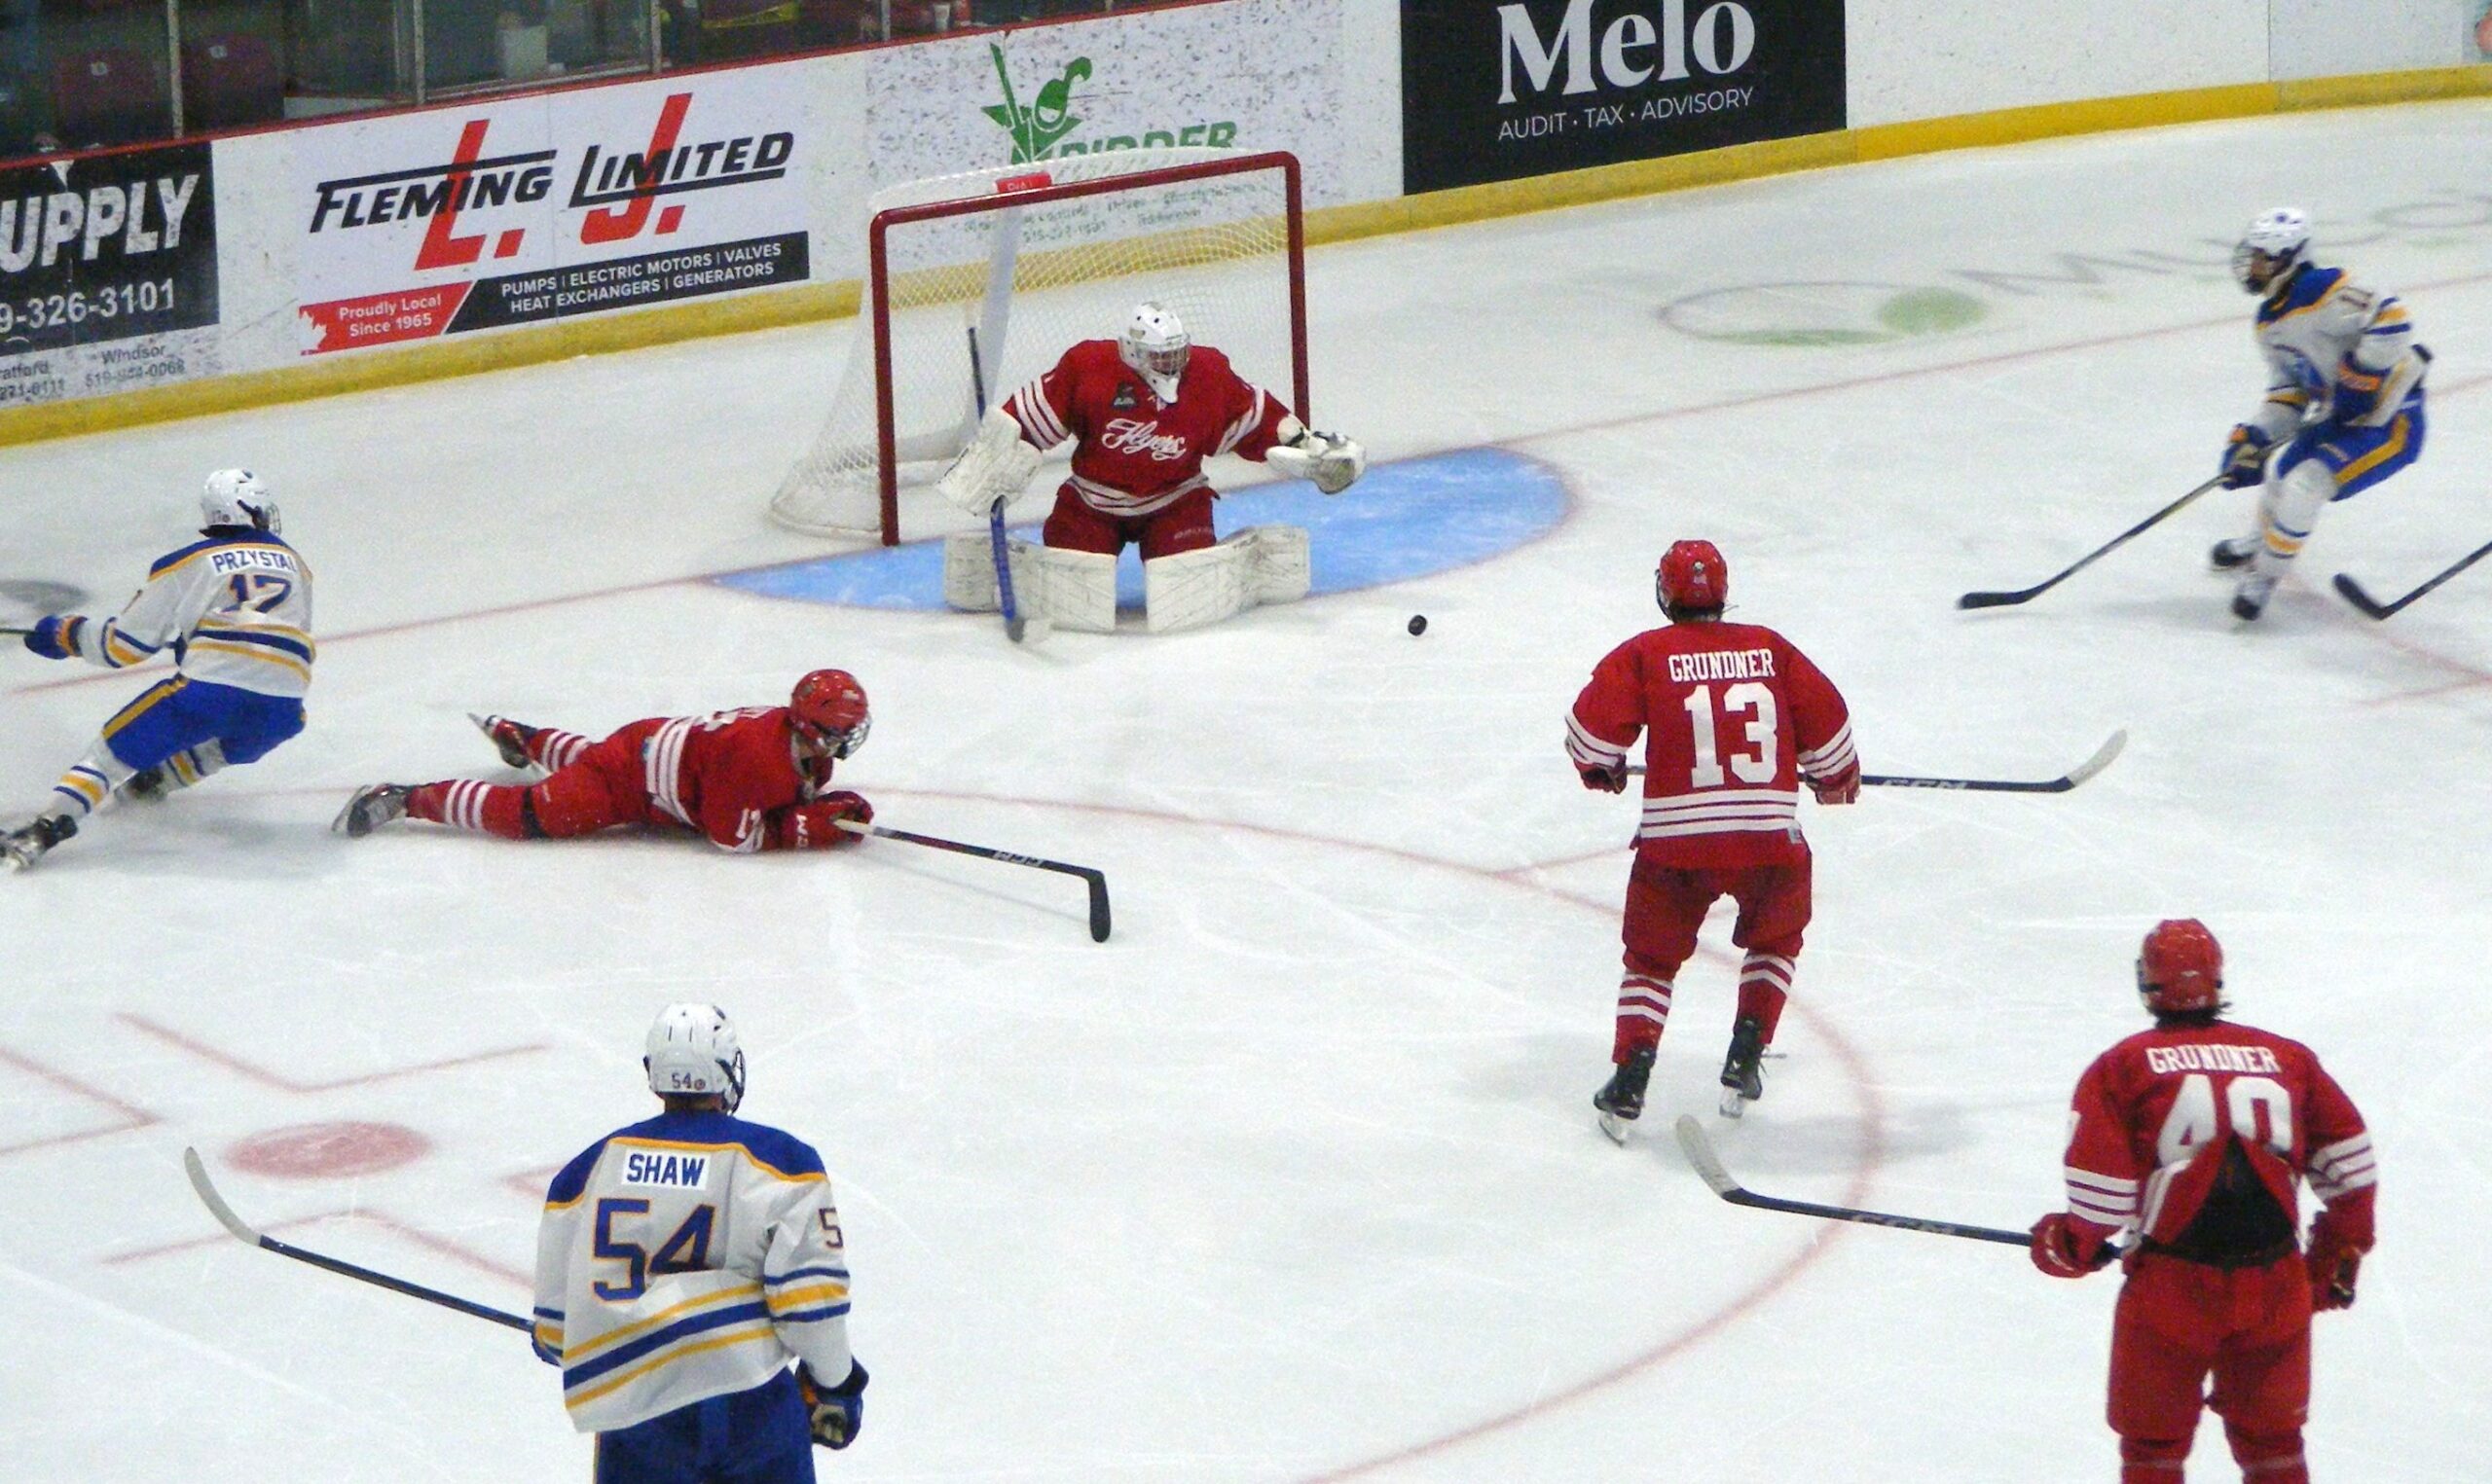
1567, 623, 1859, 866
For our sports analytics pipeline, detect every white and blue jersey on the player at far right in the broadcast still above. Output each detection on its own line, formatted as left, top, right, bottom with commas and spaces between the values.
2251, 264, 2430, 441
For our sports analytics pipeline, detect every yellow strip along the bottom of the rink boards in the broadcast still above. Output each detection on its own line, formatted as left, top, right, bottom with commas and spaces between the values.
0, 65, 2492, 446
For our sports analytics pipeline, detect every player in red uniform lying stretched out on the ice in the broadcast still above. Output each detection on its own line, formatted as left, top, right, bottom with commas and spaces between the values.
337, 670, 875, 854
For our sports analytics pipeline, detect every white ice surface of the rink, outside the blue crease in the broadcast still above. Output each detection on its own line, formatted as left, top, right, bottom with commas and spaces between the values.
0, 104, 2492, 1484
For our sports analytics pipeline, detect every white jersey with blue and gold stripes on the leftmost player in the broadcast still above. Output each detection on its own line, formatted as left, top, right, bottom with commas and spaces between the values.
59, 530, 314, 697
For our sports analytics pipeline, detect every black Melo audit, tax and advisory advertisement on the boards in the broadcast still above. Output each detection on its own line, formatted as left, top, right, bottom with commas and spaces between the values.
1403, 0, 1844, 192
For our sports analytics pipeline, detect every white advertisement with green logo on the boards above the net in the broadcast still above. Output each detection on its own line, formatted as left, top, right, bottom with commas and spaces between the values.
858, 0, 1345, 210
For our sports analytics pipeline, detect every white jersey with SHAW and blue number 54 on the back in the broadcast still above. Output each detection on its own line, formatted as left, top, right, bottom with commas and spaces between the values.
535, 1113, 850, 1431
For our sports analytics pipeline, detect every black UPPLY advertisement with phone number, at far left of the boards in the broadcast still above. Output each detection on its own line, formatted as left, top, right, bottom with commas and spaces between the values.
0, 144, 217, 406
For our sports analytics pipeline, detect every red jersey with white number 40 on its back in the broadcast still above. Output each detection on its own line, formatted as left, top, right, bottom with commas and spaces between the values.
2069, 1021, 2377, 1265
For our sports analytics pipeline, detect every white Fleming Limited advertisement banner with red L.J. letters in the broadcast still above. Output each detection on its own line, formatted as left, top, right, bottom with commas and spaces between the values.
297, 67, 818, 356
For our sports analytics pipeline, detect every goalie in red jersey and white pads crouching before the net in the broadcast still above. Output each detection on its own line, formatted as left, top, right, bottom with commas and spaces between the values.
937, 304, 1368, 633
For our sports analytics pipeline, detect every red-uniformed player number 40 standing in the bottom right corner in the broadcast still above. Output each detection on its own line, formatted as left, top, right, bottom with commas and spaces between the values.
2034, 919, 2395, 1484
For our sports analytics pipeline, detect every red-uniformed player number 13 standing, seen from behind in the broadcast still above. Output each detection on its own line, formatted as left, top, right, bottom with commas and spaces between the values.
1565, 540, 1861, 1142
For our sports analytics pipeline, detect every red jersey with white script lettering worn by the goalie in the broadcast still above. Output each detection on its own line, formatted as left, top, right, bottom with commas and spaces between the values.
1005, 342, 1291, 518
